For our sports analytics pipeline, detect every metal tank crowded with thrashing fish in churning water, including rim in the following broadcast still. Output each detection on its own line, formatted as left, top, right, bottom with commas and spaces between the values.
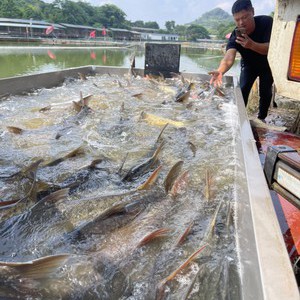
0, 66, 297, 300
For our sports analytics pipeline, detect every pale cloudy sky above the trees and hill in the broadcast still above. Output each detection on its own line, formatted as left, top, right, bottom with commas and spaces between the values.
44, 0, 275, 28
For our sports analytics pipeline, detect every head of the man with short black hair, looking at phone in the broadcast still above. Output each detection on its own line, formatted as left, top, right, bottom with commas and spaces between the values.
231, 0, 255, 34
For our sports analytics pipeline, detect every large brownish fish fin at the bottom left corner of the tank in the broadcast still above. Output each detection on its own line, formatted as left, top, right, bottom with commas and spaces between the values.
0, 254, 70, 280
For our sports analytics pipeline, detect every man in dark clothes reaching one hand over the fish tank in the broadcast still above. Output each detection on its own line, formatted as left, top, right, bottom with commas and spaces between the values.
209, 0, 273, 120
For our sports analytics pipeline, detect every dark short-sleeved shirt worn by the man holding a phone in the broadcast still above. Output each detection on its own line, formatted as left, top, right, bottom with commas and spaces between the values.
226, 16, 273, 68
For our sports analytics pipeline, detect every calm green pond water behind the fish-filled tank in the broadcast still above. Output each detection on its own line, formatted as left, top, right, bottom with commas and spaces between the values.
0, 45, 239, 78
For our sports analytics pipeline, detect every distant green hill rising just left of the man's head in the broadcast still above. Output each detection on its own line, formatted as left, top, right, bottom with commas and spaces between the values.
189, 8, 233, 34
